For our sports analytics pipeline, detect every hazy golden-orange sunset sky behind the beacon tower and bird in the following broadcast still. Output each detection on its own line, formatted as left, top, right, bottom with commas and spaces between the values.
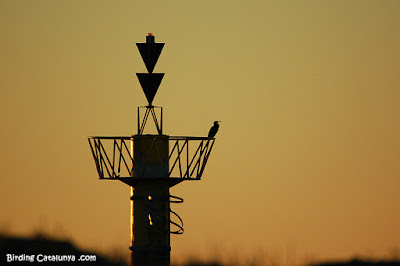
0, 0, 400, 263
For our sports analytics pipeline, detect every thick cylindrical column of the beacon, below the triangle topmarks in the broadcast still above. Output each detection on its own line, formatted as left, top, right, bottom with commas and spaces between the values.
131, 135, 171, 266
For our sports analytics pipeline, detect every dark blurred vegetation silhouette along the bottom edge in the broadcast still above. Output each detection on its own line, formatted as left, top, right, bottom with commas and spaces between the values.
0, 233, 400, 266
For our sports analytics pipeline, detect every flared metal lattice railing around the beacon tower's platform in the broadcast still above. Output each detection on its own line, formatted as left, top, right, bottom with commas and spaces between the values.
88, 136, 215, 179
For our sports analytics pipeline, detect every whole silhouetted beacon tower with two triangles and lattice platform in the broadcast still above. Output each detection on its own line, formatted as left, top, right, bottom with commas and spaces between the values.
89, 33, 215, 266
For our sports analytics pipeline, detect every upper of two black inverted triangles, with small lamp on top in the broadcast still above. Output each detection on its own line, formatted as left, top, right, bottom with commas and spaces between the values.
136, 33, 165, 73
